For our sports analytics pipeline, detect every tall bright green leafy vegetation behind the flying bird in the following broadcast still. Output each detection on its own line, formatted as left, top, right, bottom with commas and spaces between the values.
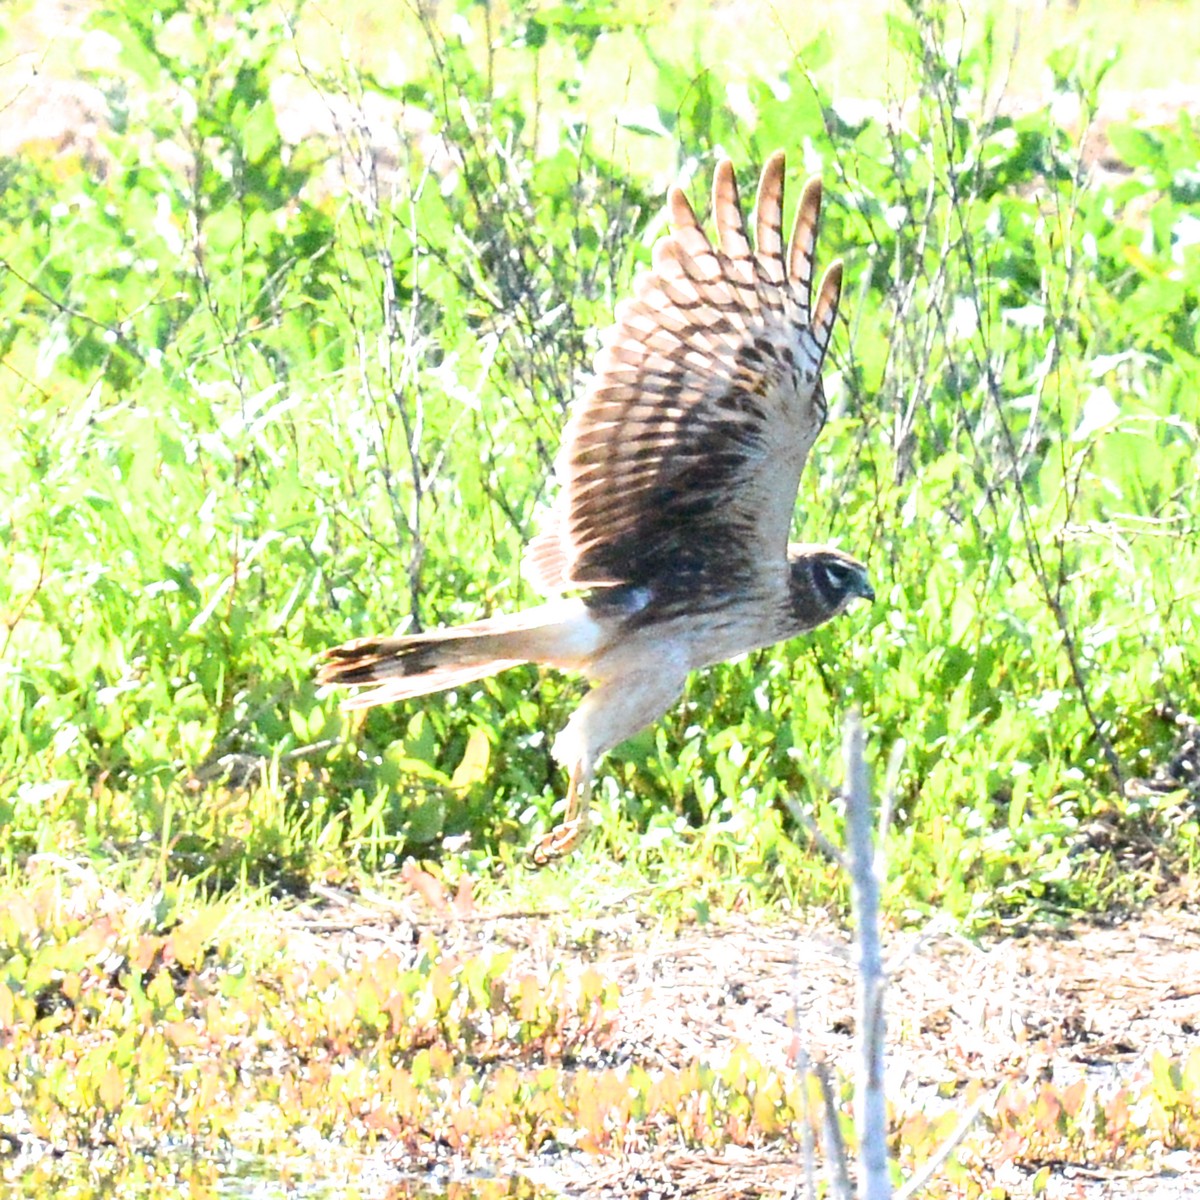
0, 4, 1200, 920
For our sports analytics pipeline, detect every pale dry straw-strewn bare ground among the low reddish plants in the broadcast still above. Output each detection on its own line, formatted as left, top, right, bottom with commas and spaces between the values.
278, 890, 1200, 1200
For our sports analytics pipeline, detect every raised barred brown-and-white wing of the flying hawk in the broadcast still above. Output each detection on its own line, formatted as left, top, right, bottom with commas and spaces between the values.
526, 152, 841, 592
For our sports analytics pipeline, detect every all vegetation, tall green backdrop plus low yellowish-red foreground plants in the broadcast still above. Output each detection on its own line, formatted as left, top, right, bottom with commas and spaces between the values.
0, 0, 1200, 1182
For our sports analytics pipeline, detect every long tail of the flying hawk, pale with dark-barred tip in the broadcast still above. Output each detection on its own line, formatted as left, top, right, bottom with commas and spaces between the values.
317, 602, 595, 708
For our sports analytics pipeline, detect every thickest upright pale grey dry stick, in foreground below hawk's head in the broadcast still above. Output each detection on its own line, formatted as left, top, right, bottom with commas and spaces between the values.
845, 712, 892, 1200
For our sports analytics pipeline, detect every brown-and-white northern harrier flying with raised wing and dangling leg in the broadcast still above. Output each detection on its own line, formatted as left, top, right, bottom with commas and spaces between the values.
318, 152, 875, 863
